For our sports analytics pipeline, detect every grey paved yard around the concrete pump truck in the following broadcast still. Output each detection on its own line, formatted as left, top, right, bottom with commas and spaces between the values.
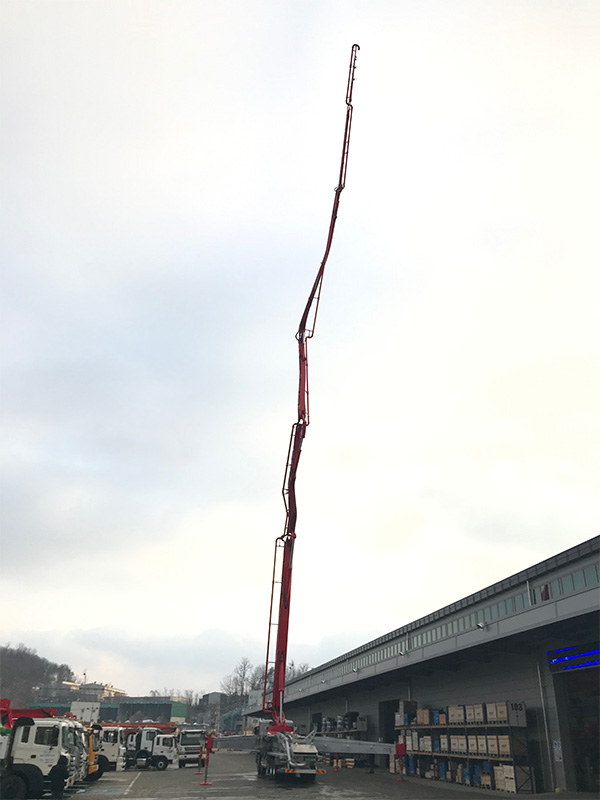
65, 751, 597, 800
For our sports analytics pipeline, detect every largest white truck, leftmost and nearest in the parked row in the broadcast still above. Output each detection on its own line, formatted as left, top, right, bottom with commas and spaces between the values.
0, 717, 81, 800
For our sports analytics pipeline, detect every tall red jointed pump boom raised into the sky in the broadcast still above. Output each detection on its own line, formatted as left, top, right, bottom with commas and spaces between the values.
263, 44, 360, 733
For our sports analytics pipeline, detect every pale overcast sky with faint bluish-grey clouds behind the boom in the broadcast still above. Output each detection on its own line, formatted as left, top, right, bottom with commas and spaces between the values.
0, 0, 600, 694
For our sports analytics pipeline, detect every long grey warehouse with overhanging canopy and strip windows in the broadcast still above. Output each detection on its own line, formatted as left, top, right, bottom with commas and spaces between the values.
286, 537, 600, 792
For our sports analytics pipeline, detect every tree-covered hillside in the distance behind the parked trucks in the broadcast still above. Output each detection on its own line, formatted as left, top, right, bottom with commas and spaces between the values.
0, 644, 75, 708
